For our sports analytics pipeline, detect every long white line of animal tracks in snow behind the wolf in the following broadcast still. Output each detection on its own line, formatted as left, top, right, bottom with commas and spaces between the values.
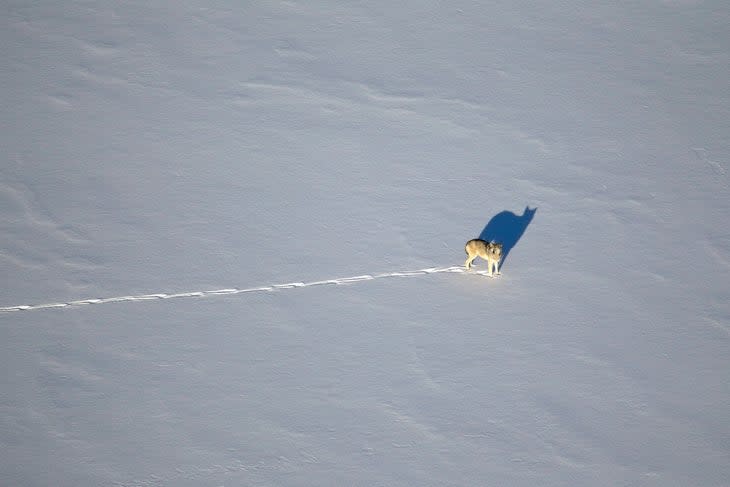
0, 266, 488, 312
